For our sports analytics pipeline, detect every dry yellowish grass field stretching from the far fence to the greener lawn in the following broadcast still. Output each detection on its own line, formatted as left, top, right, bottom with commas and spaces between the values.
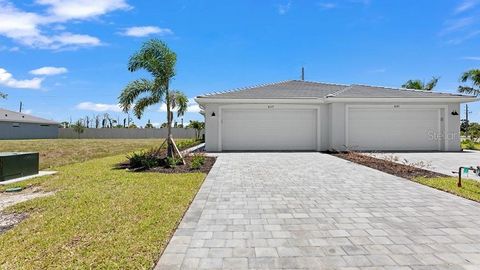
0, 139, 180, 169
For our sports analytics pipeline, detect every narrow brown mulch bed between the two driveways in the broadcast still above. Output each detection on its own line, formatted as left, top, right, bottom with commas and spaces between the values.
330, 152, 449, 180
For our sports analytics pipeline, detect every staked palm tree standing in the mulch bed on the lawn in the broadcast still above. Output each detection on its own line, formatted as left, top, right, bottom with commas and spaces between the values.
119, 39, 188, 157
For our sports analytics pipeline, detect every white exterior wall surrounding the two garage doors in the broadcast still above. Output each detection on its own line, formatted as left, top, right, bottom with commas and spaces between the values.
204, 102, 461, 152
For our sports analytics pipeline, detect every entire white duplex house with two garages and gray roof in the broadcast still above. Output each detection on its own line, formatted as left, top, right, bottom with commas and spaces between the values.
196, 80, 477, 151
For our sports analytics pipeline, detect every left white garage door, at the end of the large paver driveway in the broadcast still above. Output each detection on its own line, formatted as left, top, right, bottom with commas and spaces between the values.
221, 109, 317, 151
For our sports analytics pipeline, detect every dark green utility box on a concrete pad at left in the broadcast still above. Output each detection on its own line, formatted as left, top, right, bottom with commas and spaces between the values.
0, 152, 39, 181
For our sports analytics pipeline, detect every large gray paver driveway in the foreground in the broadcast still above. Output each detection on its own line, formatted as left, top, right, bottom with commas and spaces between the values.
157, 153, 480, 269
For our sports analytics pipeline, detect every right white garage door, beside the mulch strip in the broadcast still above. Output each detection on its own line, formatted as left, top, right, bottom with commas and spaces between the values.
347, 108, 440, 151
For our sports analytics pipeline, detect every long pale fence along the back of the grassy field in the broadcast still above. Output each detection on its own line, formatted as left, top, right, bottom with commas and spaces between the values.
58, 128, 200, 139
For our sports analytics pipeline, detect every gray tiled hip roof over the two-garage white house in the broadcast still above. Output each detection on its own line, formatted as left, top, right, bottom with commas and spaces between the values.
199, 80, 471, 99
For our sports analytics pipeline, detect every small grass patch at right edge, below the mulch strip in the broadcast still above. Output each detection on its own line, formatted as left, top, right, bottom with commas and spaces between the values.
415, 177, 480, 202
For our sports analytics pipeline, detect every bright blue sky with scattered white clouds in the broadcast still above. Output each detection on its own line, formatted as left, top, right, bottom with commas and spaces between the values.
0, 0, 480, 125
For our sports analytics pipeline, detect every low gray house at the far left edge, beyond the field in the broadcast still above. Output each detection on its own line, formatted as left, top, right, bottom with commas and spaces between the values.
0, 109, 59, 140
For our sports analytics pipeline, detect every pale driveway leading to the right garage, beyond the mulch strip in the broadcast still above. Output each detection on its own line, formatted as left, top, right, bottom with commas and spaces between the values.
370, 150, 480, 180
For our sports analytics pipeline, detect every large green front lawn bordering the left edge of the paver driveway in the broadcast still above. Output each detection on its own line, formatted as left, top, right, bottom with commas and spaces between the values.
0, 153, 205, 269
